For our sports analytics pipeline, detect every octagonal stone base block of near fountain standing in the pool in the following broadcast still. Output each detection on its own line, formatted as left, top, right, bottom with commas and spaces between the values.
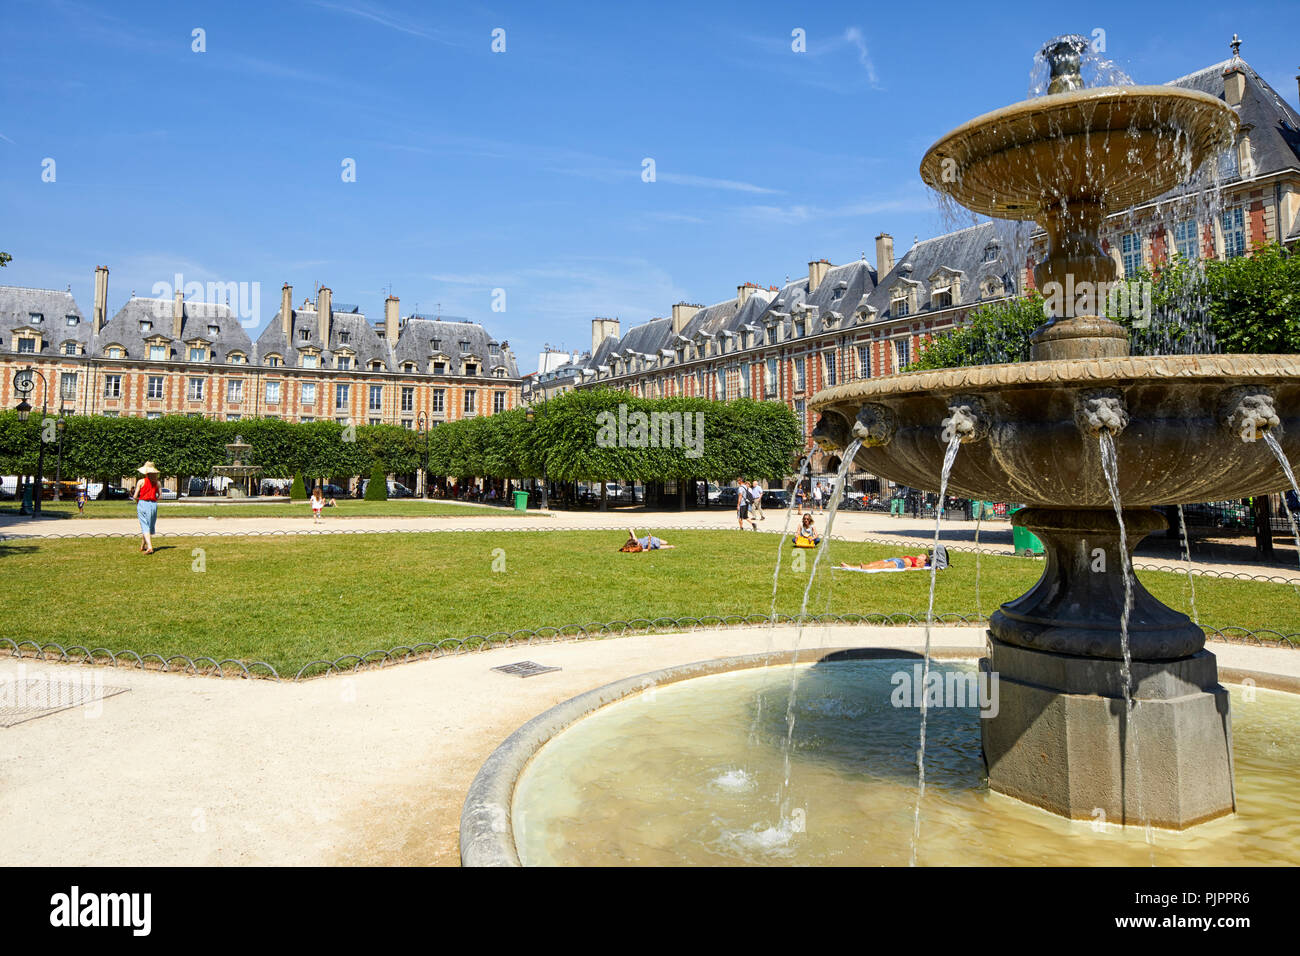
980, 633, 1236, 830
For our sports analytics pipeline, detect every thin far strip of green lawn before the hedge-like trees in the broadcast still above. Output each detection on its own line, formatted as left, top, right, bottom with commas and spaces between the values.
0, 498, 536, 520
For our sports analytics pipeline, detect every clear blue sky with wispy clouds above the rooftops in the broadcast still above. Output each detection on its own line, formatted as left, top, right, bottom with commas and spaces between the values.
0, 0, 1296, 371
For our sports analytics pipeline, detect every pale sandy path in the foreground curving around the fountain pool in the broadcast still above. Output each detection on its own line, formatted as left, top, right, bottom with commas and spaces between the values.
0, 627, 1300, 866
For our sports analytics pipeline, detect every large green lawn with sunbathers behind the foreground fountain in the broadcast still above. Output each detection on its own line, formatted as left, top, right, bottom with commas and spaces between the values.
0, 531, 1300, 674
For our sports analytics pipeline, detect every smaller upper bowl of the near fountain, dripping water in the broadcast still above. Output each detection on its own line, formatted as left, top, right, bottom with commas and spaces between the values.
920, 86, 1238, 220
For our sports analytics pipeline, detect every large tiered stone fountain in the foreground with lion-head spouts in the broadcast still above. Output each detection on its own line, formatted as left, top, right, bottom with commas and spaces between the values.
814, 38, 1300, 829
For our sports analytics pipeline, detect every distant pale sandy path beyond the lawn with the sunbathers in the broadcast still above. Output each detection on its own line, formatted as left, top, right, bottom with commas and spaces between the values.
0, 503, 1300, 581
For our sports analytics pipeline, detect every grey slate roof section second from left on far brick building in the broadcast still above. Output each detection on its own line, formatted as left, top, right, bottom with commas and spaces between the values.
94, 295, 254, 363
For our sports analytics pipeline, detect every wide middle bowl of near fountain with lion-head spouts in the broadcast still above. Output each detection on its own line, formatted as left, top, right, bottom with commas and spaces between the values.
813, 355, 1300, 509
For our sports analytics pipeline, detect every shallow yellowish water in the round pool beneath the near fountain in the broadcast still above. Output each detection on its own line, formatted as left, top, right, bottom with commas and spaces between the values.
514, 661, 1300, 866
